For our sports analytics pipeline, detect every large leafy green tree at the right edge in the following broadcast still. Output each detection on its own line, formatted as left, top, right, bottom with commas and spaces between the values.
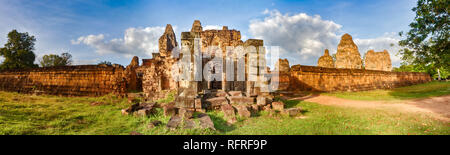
399, 0, 450, 80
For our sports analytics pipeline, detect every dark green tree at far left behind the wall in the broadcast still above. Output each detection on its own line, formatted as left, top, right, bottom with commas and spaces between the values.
0, 30, 37, 69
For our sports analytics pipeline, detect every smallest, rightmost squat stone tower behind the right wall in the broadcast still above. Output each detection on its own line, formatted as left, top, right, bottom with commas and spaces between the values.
364, 50, 392, 71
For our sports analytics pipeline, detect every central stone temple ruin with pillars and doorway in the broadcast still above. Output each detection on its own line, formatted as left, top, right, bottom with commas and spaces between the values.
138, 20, 280, 122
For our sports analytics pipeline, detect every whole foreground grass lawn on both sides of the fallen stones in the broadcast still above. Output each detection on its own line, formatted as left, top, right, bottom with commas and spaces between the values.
0, 92, 450, 135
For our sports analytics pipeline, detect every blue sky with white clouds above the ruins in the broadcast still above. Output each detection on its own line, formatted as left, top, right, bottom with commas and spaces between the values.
0, 0, 416, 66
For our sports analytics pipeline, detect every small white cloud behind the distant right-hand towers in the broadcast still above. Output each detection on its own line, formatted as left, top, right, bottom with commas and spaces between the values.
354, 32, 401, 66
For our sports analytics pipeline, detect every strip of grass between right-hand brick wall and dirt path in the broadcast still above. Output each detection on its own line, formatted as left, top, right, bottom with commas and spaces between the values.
323, 81, 450, 101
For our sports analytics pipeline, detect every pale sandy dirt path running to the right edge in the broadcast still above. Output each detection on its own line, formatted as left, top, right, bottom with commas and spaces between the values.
289, 94, 450, 122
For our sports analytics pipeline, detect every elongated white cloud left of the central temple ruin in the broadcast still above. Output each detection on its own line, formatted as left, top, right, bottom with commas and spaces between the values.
71, 27, 169, 57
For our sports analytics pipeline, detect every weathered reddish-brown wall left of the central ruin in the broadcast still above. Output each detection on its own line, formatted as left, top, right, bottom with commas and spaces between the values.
0, 65, 127, 96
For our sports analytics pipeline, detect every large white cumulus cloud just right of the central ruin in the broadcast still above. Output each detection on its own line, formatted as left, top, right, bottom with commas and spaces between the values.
249, 10, 342, 65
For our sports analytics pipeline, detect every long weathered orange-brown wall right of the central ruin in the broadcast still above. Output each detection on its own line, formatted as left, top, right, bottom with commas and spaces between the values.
289, 65, 431, 92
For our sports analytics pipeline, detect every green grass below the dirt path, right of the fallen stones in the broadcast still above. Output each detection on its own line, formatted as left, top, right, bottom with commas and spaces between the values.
223, 100, 450, 135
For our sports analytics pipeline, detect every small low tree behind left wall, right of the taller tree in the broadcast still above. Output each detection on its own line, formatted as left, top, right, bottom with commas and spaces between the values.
39, 53, 72, 67
